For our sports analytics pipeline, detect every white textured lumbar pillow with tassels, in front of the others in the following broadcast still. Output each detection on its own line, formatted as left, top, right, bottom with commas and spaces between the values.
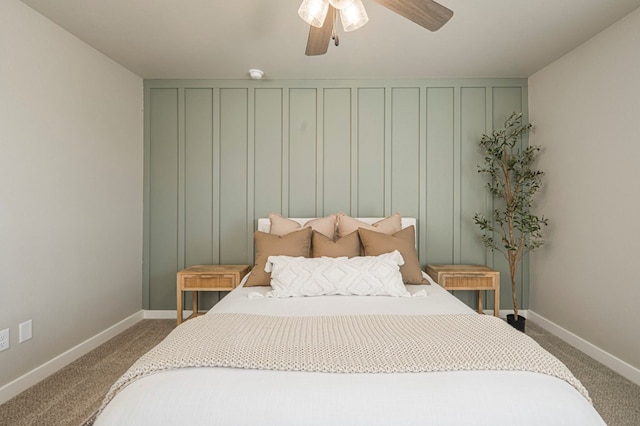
264, 250, 410, 297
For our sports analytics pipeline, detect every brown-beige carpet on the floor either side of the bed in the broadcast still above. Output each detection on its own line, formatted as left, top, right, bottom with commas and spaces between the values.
0, 320, 640, 426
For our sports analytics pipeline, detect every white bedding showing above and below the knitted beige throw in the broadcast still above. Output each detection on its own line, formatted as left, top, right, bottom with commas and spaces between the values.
95, 274, 604, 426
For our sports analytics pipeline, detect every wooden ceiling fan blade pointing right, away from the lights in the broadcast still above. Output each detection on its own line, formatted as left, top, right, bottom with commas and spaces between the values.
375, 0, 453, 31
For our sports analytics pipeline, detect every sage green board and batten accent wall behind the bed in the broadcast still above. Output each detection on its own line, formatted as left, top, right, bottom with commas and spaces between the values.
143, 79, 528, 310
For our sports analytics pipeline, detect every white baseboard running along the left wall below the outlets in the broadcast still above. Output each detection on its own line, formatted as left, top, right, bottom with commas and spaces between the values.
0, 311, 142, 404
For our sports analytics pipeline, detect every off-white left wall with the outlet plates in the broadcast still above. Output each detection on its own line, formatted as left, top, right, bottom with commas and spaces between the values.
0, 0, 143, 402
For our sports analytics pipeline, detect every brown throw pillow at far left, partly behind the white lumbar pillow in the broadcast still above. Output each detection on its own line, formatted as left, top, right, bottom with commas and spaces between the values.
244, 228, 312, 287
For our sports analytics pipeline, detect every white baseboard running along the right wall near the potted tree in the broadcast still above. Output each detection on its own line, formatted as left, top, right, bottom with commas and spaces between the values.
529, 311, 640, 386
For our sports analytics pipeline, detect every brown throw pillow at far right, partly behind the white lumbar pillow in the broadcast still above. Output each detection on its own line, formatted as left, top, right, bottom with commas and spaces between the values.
358, 225, 429, 284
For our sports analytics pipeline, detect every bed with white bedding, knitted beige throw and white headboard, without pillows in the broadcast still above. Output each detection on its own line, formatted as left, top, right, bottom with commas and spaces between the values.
94, 218, 604, 426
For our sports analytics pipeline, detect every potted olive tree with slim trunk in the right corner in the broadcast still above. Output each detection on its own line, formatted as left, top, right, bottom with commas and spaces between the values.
473, 112, 548, 331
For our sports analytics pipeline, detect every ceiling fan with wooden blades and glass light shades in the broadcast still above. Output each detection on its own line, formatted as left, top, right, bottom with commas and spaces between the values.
298, 0, 453, 56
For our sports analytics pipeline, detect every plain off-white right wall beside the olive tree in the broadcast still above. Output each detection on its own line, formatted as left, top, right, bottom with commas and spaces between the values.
529, 9, 640, 377
